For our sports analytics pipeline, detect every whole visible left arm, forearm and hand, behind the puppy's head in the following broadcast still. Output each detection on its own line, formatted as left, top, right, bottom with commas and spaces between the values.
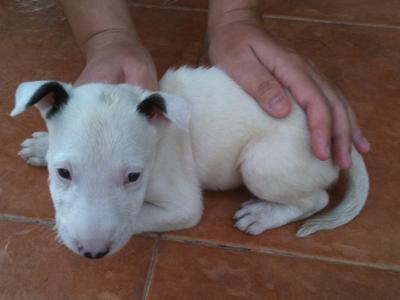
61, 0, 158, 90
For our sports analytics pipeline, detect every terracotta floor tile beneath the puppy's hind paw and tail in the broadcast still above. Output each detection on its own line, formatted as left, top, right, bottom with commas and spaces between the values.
165, 21, 400, 264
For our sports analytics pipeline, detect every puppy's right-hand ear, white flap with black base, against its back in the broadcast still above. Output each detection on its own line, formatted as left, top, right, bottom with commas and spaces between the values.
137, 92, 190, 130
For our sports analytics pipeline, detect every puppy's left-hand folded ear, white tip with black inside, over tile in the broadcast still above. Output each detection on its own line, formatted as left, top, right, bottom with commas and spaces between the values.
10, 80, 72, 119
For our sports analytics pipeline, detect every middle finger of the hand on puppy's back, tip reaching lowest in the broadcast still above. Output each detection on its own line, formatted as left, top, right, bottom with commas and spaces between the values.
310, 71, 351, 169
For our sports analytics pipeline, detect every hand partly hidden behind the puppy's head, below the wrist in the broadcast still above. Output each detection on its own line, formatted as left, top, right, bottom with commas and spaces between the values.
75, 31, 158, 90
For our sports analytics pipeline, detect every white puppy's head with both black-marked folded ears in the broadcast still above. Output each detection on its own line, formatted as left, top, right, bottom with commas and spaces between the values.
11, 81, 189, 258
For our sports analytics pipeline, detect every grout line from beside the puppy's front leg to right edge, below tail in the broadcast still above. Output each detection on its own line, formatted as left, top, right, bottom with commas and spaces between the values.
160, 235, 400, 272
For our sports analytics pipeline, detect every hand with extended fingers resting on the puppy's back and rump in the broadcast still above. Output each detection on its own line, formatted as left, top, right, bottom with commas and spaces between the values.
209, 12, 369, 169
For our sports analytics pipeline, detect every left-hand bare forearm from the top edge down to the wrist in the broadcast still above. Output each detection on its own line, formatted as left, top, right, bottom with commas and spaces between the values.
61, 0, 139, 54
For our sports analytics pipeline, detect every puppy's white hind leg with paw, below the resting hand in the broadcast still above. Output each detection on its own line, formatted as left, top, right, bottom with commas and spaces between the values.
234, 133, 337, 234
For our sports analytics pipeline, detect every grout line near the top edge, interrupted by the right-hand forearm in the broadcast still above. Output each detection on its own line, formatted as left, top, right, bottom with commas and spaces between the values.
129, 3, 400, 29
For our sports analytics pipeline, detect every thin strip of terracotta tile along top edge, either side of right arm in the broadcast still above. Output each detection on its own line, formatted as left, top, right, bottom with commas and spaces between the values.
129, 0, 400, 25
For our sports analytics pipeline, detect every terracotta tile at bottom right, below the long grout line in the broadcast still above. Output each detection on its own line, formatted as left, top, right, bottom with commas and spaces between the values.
149, 242, 400, 300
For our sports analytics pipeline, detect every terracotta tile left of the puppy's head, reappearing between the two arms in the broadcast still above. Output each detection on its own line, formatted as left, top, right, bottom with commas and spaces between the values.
0, 1, 205, 218
